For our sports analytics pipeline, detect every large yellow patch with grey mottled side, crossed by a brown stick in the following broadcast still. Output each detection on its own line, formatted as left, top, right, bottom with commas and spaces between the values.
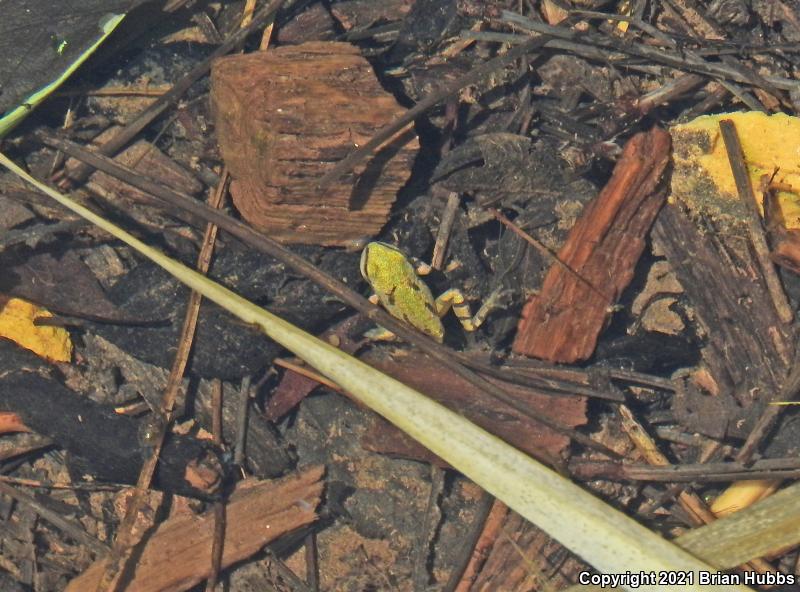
670, 111, 800, 229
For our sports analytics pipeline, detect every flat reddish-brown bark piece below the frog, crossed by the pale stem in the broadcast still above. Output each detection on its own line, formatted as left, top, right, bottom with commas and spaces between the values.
362, 353, 586, 466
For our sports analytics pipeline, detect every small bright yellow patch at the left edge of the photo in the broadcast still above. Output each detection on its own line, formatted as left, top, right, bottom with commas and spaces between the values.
0, 298, 72, 362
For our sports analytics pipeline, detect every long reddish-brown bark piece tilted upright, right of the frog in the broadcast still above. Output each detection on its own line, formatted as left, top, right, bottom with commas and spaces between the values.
514, 128, 670, 363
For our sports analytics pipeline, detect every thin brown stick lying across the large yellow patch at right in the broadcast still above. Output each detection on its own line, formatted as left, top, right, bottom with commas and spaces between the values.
719, 119, 794, 323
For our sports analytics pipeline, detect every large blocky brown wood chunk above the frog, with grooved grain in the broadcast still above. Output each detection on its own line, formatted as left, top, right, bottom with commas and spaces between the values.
211, 42, 418, 245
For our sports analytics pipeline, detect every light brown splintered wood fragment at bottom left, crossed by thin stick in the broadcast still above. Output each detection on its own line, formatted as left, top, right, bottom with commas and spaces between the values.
66, 467, 324, 592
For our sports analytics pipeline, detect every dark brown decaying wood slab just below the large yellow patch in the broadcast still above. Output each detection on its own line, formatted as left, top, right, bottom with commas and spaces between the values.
653, 204, 793, 438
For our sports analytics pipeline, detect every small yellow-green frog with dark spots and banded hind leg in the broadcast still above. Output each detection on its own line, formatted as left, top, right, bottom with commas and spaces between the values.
361, 242, 498, 343
